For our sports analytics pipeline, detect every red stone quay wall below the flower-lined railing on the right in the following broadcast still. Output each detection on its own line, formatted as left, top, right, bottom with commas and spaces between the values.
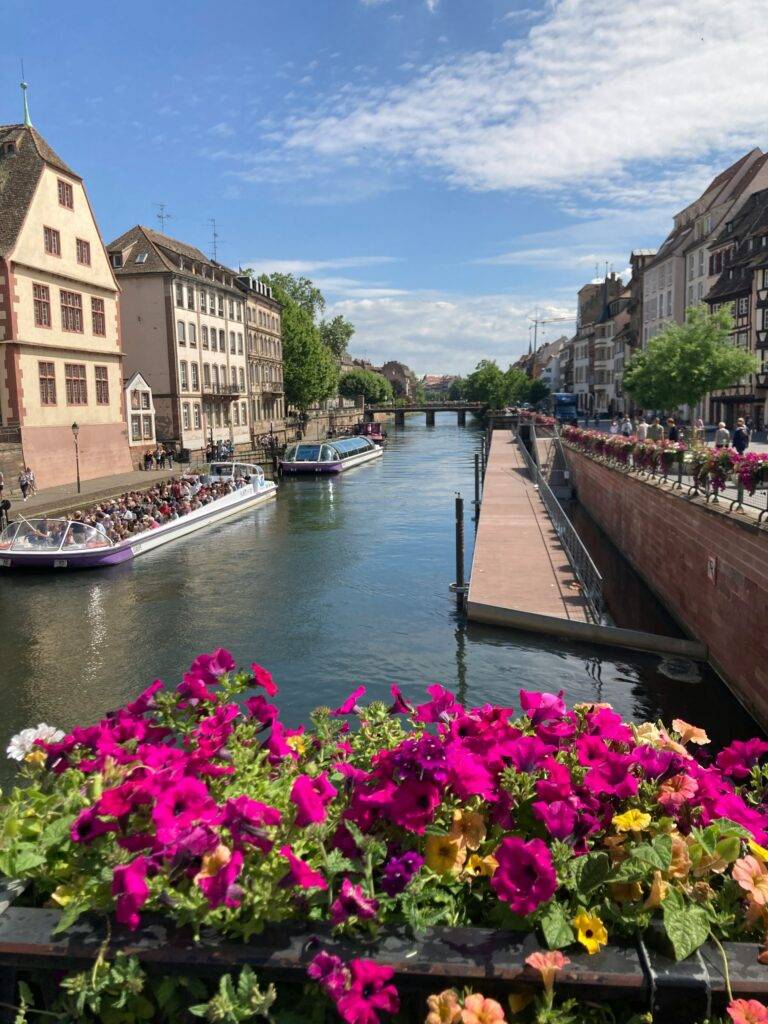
565, 446, 768, 729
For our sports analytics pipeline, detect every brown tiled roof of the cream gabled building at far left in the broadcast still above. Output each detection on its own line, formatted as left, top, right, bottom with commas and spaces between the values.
0, 125, 81, 256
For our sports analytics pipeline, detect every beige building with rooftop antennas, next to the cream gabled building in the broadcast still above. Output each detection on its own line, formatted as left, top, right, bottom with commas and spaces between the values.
108, 232, 251, 453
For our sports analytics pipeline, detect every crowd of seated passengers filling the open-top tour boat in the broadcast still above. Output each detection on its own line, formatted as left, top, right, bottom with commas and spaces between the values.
20, 476, 247, 546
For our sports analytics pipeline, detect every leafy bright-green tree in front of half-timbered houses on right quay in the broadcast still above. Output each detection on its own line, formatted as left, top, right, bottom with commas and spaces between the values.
623, 306, 758, 412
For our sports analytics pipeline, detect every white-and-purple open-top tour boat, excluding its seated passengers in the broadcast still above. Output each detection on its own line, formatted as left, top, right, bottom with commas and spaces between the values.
0, 463, 278, 569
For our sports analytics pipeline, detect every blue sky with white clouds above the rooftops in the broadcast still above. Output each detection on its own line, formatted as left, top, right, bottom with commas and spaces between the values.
0, 0, 768, 374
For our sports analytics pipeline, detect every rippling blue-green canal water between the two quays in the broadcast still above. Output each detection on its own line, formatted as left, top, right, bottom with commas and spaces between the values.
0, 414, 755, 779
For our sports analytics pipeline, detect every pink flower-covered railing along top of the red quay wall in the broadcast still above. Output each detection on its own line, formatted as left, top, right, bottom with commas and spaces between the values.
561, 427, 768, 521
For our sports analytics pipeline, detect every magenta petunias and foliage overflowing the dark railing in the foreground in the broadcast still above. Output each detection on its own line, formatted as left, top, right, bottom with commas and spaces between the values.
0, 650, 768, 1024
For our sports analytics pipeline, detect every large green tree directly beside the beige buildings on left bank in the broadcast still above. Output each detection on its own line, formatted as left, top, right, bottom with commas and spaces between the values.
272, 283, 339, 413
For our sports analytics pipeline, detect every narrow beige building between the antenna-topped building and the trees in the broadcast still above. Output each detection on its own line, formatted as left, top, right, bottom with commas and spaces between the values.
237, 276, 286, 439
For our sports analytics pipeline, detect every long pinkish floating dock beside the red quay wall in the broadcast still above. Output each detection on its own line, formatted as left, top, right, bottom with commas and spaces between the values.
467, 430, 707, 658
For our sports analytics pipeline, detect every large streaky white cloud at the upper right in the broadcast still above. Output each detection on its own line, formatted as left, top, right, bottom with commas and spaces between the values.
285, 0, 768, 203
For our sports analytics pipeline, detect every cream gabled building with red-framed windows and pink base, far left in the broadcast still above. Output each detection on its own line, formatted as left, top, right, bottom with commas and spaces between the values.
0, 117, 131, 487
